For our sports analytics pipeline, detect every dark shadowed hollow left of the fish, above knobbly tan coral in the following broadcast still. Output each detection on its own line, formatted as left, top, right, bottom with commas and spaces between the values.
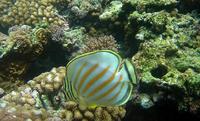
25, 41, 70, 80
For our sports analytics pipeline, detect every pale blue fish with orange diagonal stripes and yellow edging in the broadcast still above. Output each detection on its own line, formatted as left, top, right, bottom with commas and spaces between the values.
63, 50, 137, 107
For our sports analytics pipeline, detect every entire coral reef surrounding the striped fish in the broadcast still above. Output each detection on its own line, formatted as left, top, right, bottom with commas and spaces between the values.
0, 0, 200, 121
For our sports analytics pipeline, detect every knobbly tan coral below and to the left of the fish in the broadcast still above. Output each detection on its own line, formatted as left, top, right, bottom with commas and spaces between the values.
0, 67, 126, 121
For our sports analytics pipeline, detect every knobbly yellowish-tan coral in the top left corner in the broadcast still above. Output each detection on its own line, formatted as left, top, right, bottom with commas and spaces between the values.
0, 0, 65, 27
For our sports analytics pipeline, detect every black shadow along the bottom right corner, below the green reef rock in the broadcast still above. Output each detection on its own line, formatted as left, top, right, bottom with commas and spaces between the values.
123, 100, 200, 121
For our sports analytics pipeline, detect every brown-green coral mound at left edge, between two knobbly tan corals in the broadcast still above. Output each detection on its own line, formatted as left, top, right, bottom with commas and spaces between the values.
0, 25, 48, 90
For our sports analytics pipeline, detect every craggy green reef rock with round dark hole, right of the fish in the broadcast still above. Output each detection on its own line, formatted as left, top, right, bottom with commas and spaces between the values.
129, 1, 200, 110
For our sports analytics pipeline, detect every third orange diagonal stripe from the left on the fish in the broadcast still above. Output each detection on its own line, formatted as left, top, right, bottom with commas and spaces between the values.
83, 66, 110, 93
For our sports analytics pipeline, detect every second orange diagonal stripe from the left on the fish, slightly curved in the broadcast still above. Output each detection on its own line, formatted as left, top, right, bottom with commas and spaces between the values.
78, 64, 99, 93
